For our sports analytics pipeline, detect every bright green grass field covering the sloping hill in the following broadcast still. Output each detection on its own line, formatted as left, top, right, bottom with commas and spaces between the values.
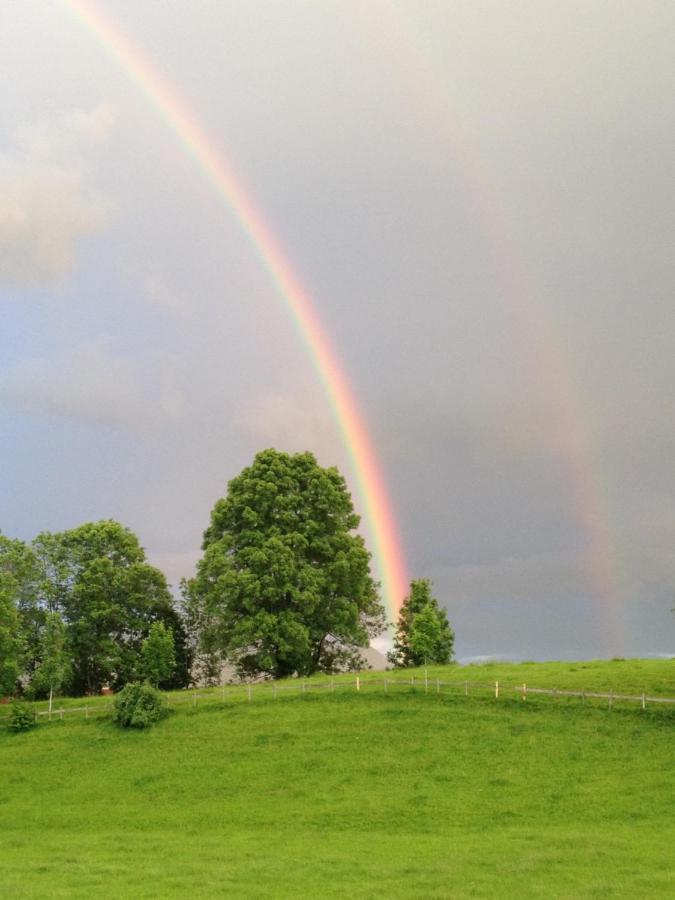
0, 661, 675, 898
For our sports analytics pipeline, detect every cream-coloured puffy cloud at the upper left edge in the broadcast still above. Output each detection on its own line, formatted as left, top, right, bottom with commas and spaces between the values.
0, 106, 112, 286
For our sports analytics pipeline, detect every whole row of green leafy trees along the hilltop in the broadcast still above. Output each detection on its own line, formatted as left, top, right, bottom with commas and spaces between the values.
0, 450, 454, 697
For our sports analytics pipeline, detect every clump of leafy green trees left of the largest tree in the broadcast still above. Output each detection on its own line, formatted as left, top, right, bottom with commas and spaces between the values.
0, 520, 190, 695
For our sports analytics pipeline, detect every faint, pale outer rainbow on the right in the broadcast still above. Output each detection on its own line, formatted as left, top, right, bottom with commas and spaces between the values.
359, 0, 628, 654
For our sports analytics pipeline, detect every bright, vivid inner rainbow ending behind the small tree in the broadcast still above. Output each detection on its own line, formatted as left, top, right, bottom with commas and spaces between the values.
62, 0, 408, 616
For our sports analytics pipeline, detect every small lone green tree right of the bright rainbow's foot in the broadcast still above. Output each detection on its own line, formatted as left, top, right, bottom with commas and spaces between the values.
388, 578, 455, 668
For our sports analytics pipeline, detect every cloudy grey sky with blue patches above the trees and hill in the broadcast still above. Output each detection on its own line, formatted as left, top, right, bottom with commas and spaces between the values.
0, 0, 675, 660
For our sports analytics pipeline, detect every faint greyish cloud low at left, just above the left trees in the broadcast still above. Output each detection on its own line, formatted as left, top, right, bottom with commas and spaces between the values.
0, 343, 182, 431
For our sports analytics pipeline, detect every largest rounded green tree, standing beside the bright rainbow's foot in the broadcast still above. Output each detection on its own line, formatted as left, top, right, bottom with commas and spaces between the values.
184, 450, 384, 678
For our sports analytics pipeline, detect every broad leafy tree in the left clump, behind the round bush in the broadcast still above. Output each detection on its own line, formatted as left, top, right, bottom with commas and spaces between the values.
34, 520, 188, 694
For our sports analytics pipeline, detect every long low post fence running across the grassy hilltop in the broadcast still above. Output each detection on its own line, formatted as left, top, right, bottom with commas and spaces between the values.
0, 674, 675, 727
